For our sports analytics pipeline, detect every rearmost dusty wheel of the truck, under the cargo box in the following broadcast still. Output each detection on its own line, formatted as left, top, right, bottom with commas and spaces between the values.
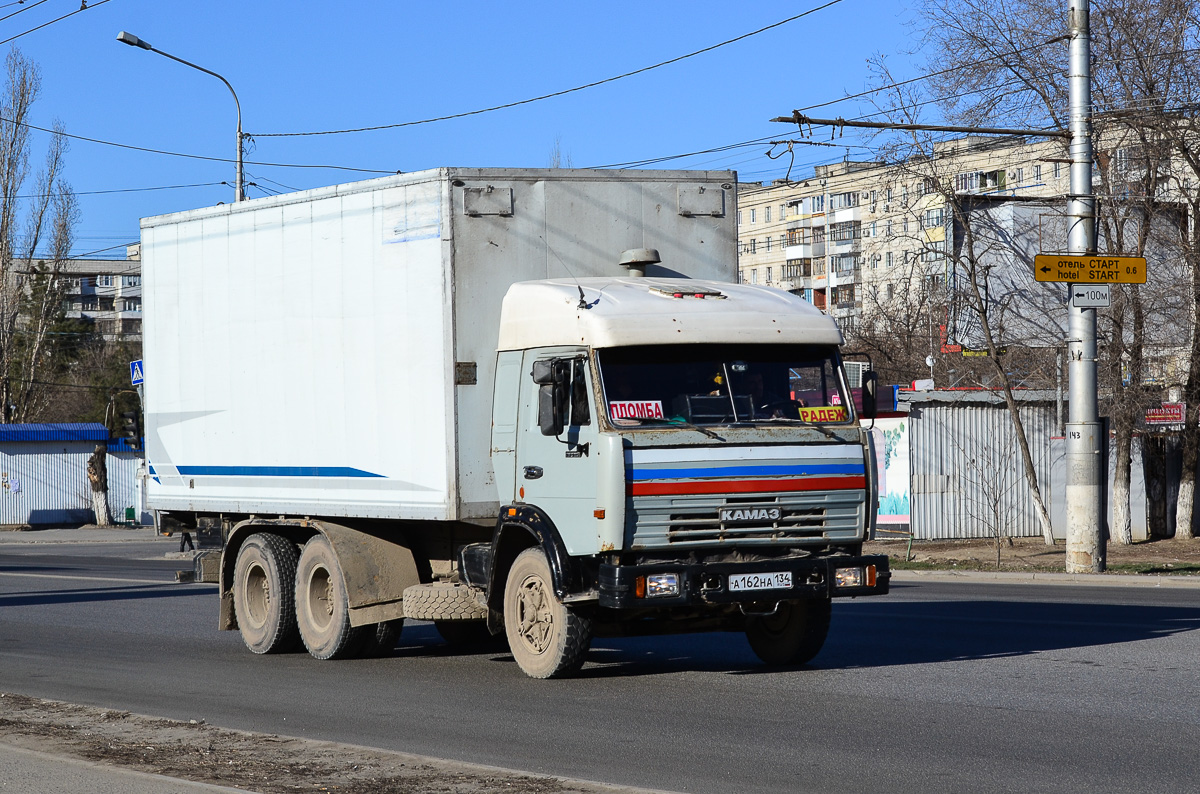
233, 533, 300, 654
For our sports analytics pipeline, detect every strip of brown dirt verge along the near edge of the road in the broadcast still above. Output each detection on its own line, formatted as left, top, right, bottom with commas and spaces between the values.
0, 693, 657, 794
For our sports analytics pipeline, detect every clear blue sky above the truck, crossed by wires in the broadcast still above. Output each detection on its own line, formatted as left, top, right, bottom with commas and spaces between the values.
7, 0, 918, 257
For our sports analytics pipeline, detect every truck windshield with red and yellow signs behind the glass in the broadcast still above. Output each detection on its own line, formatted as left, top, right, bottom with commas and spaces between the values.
598, 344, 851, 427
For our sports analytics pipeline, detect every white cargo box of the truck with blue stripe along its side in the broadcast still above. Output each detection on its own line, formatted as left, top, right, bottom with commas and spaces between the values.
142, 168, 737, 522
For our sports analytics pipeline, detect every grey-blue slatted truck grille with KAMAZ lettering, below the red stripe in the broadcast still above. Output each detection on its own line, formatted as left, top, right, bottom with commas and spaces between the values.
628, 491, 865, 549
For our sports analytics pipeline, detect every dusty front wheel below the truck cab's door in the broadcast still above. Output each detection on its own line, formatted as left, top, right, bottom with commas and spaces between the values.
504, 548, 592, 678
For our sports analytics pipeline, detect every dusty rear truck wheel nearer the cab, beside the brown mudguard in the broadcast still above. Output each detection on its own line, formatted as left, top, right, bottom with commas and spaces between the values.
295, 535, 367, 660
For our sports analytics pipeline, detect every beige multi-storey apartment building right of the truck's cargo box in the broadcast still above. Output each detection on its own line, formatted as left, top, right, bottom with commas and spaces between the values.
738, 137, 1069, 326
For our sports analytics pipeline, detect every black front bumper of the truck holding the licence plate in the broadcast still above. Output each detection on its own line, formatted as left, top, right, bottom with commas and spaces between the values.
599, 555, 892, 609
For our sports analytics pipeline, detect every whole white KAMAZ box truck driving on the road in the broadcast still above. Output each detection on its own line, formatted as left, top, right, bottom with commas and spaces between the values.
142, 168, 889, 678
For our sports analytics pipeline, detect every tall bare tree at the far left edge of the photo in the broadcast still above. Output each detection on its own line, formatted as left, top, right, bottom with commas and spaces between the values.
0, 49, 79, 422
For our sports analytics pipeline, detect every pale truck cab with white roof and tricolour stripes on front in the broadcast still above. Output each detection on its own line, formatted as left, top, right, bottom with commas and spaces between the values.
463, 278, 888, 674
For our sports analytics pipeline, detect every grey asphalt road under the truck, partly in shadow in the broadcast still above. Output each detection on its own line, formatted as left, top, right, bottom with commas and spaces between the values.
0, 541, 1200, 794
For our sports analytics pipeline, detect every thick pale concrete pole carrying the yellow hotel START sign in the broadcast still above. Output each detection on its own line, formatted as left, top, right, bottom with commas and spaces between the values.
1067, 0, 1105, 573
